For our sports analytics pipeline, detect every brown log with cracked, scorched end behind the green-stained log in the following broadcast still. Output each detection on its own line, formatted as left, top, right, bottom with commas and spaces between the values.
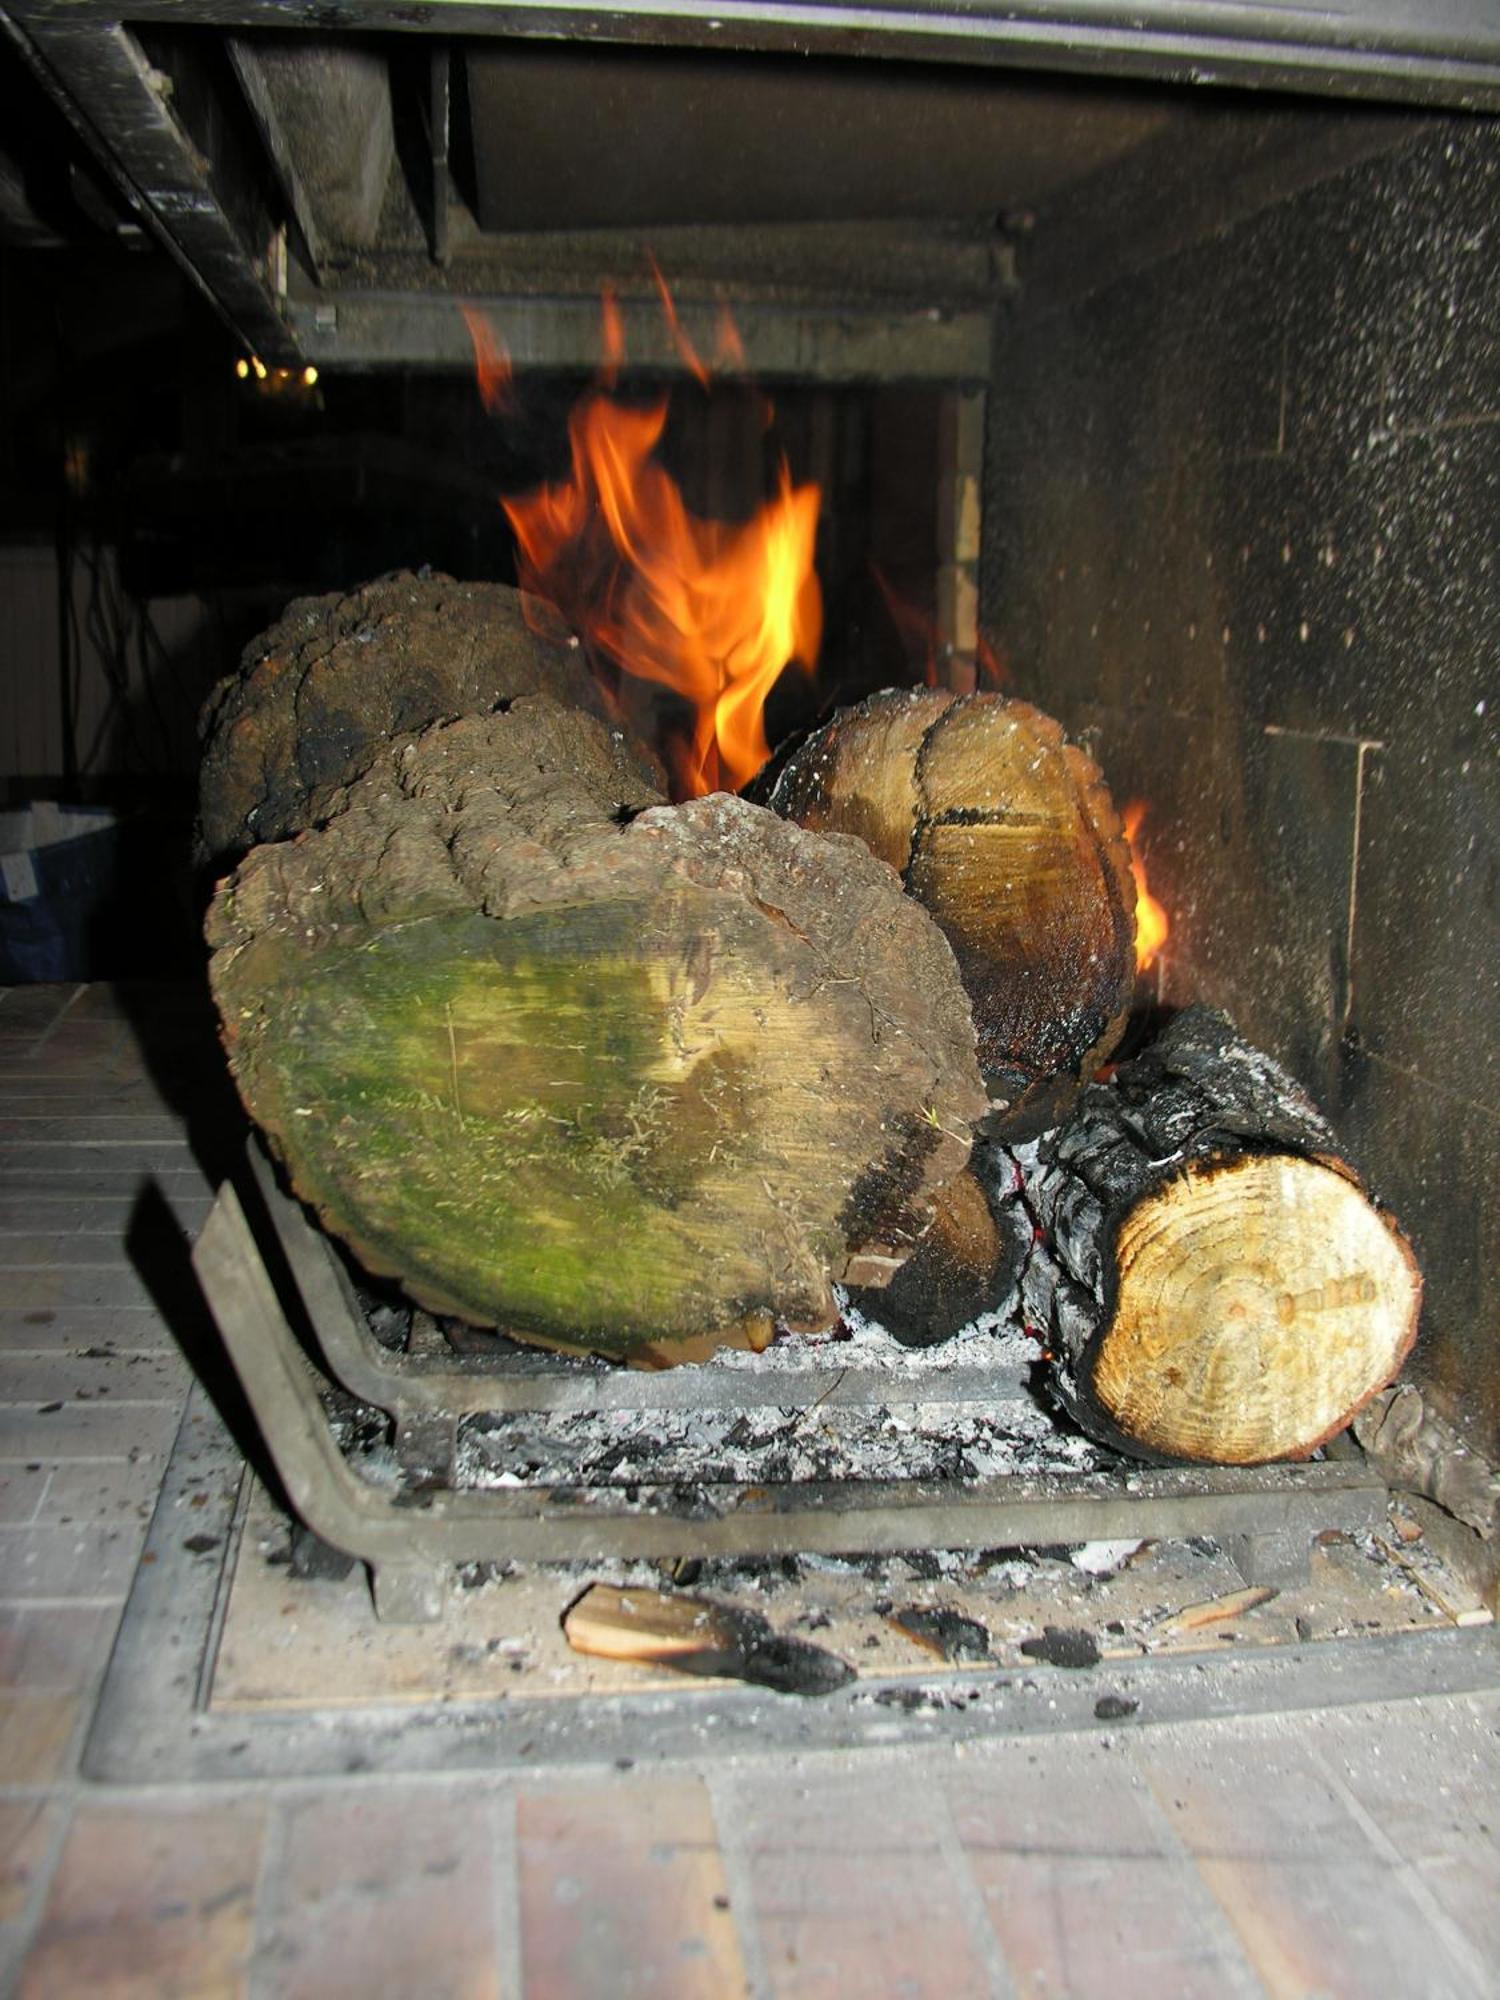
770, 688, 1136, 1132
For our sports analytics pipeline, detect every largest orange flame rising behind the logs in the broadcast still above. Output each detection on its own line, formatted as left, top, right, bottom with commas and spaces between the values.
502, 284, 822, 798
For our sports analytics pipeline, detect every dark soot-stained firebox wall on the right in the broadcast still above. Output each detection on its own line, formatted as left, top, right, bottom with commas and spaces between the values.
984, 120, 1500, 1454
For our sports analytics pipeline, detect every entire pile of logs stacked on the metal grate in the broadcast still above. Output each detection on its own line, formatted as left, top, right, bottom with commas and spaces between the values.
202, 578, 1420, 1464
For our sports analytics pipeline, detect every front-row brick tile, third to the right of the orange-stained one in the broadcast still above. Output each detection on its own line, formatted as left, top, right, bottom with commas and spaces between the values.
1136, 1726, 1472, 2000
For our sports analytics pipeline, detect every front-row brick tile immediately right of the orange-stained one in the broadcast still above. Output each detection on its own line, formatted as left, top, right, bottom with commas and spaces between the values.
720, 1770, 990, 2000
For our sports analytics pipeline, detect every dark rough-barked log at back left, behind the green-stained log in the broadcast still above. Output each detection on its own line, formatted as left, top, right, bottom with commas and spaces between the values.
198, 574, 598, 866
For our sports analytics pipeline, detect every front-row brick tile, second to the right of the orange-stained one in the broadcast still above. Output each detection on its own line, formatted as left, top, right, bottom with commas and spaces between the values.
946, 1742, 1260, 2000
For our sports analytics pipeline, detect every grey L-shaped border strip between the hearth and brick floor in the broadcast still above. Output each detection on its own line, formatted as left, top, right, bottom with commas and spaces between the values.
82, 1386, 1500, 1784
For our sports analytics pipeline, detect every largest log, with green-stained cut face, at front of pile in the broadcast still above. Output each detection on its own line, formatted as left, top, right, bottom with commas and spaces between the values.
208, 696, 984, 1362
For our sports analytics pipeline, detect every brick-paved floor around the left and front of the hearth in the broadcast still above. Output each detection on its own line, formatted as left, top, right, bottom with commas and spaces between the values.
0, 990, 1500, 2000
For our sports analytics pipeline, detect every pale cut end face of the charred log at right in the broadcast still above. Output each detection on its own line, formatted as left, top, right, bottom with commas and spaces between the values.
1086, 1154, 1422, 1464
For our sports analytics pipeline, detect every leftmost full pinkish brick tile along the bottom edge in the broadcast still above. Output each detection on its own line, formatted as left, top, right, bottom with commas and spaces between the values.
16, 1798, 264, 2000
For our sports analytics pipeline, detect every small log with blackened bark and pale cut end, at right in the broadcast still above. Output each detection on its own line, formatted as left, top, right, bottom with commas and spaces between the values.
1016, 1008, 1422, 1464
